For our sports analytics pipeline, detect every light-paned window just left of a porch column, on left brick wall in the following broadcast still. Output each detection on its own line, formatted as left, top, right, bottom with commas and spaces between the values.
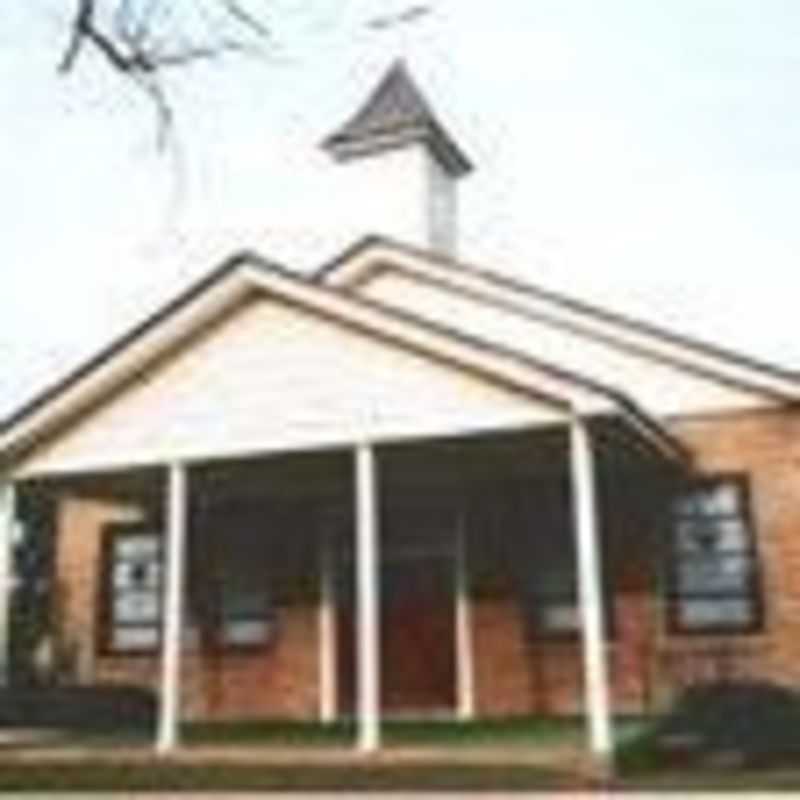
105, 529, 162, 651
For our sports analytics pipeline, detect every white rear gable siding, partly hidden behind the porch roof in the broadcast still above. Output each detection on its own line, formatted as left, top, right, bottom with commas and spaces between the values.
356, 268, 768, 415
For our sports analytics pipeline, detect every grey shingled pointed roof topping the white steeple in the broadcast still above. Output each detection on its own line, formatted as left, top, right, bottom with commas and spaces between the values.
322, 60, 472, 176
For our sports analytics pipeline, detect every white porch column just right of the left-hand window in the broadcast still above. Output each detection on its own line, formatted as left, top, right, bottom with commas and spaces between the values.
156, 463, 188, 753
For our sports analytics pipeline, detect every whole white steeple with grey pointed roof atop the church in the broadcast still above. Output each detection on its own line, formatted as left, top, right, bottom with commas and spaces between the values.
322, 60, 473, 255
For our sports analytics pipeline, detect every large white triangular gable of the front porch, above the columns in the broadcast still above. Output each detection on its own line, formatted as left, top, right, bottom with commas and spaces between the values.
16, 296, 557, 476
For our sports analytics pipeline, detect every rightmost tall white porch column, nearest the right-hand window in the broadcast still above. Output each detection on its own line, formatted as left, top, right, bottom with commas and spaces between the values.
570, 416, 613, 768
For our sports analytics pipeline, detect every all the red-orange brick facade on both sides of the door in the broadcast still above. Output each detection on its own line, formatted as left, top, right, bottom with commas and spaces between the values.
54, 411, 800, 718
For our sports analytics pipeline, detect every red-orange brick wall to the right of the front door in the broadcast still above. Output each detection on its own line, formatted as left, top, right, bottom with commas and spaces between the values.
473, 411, 800, 716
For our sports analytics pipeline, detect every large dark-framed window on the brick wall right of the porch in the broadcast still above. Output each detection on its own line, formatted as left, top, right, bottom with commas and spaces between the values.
668, 478, 761, 633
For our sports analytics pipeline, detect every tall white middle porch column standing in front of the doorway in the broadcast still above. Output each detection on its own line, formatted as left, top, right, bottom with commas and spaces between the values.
355, 444, 381, 753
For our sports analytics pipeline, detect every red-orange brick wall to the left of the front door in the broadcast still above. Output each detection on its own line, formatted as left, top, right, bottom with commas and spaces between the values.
53, 496, 319, 719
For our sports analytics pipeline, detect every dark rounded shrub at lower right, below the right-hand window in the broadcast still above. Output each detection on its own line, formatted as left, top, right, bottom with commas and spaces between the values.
620, 681, 800, 769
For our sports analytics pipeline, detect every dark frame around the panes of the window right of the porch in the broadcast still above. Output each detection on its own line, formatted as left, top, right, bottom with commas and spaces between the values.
665, 472, 765, 637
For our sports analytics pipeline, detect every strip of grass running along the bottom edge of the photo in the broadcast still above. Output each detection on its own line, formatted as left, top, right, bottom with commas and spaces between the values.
0, 760, 800, 796
